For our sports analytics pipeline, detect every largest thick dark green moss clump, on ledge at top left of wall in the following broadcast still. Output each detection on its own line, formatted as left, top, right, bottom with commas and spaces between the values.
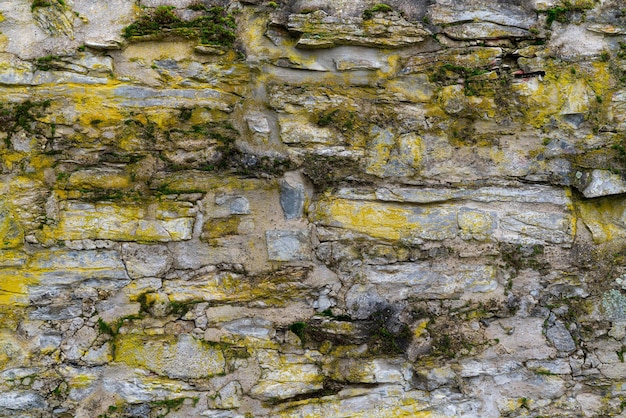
122, 4, 236, 48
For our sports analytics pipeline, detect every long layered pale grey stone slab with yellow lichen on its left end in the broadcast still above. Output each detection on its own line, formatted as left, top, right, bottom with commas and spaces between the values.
313, 188, 573, 246
